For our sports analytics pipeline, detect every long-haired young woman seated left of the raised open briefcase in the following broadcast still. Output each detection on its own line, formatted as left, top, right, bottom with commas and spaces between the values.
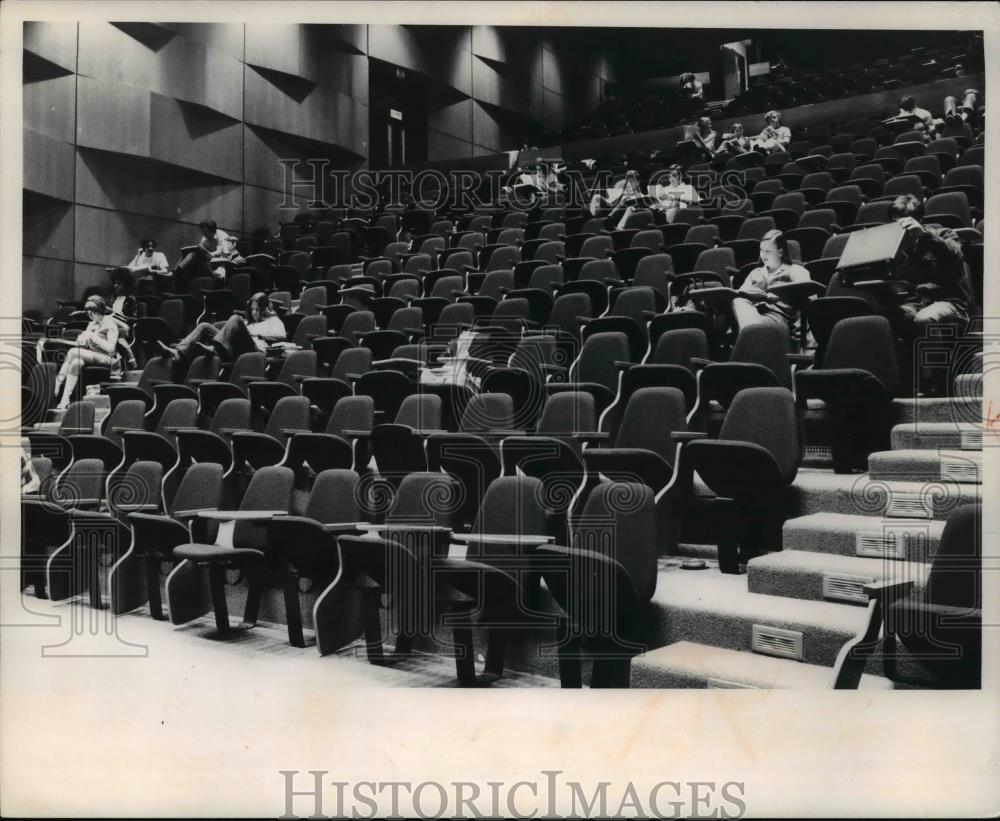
733, 230, 810, 333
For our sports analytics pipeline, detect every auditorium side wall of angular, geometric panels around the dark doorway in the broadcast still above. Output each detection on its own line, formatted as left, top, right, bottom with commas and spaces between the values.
23, 21, 612, 310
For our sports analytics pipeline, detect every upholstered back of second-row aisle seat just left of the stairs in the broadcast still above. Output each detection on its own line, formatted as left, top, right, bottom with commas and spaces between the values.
719, 388, 802, 484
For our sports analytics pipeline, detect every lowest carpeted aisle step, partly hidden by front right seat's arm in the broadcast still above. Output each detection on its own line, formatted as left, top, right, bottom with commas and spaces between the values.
632, 641, 893, 690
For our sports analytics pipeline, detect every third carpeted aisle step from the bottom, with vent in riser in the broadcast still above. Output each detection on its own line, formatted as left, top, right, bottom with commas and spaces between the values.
747, 550, 930, 607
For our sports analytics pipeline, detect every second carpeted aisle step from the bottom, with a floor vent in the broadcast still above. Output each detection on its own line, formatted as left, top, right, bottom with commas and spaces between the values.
643, 569, 866, 666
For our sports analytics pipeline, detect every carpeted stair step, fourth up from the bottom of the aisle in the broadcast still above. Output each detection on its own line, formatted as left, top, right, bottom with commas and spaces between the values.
782, 513, 944, 562
